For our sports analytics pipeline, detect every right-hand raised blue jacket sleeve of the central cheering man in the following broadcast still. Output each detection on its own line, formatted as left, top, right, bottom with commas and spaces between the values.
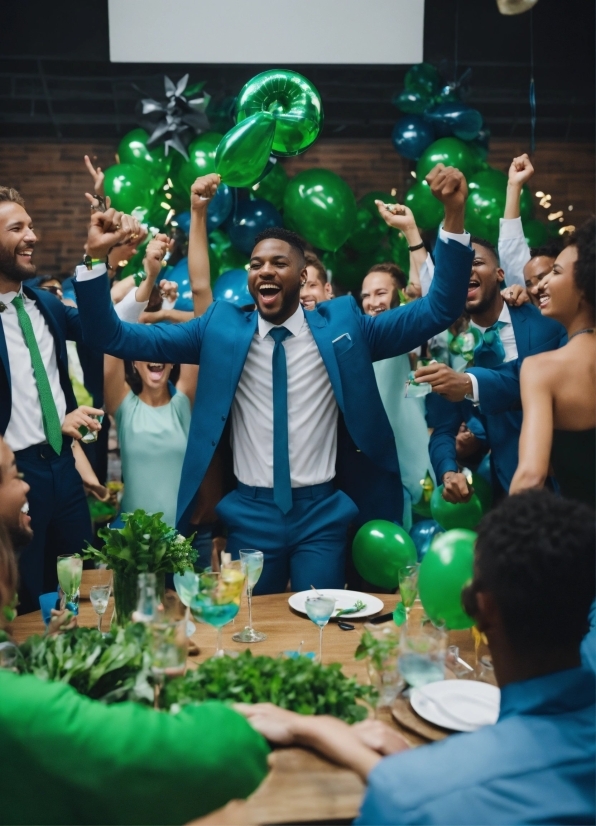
360, 235, 474, 361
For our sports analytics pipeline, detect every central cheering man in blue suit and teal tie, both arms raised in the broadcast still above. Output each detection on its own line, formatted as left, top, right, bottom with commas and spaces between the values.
76, 166, 472, 593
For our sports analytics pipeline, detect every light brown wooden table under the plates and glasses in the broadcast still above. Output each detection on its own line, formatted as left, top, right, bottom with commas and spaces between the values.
13, 570, 474, 826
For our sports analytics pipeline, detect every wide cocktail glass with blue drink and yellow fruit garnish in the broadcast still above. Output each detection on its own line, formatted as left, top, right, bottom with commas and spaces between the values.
190, 568, 244, 657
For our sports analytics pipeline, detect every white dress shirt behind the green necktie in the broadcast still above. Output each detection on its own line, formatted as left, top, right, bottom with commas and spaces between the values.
0, 264, 147, 451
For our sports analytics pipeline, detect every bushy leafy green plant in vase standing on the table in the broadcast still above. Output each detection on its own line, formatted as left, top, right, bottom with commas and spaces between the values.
84, 509, 197, 625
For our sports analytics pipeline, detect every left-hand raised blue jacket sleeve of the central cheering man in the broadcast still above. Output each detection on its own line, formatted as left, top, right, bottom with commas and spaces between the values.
75, 275, 205, 364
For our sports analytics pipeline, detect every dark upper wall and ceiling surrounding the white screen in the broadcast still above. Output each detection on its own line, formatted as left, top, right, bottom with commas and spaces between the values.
0, 0, 594, 140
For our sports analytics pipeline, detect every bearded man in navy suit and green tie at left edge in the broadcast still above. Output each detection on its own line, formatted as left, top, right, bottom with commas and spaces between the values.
0, 187, 145, 613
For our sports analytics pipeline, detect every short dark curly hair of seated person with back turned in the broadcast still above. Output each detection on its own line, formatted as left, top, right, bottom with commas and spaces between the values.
473, 490, 596, 653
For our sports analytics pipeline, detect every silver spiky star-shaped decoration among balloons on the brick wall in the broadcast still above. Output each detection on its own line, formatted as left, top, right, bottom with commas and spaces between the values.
141, 74, 210, 158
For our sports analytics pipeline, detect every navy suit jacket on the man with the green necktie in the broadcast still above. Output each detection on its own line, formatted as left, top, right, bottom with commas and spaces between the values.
0, 285, 83, 435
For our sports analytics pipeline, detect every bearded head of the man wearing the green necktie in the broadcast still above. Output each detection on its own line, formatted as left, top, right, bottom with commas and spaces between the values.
0, 201, 37, 292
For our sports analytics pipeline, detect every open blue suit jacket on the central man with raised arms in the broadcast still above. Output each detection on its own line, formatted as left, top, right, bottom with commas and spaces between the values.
76, 235, 472, 531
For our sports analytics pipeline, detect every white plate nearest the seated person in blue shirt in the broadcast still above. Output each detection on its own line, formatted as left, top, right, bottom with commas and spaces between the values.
410, 680, 501, 731
